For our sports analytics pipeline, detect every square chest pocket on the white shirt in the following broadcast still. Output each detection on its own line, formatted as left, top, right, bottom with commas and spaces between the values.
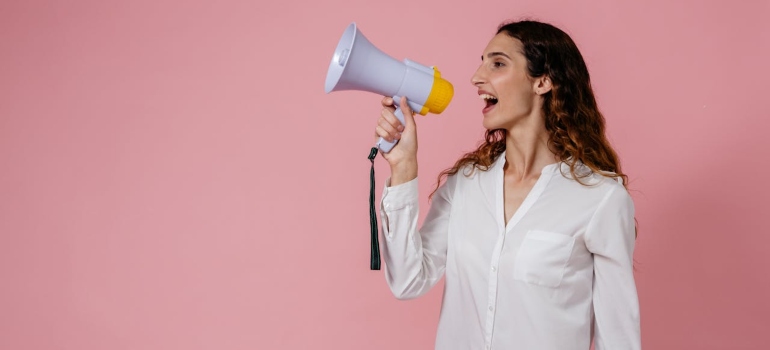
513, 230, 575, 287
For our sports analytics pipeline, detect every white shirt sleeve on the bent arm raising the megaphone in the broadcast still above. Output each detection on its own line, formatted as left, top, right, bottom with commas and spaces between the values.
380, 176, 455, 299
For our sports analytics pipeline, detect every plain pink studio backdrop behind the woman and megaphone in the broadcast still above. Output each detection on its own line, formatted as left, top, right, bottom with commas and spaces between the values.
0, 0, 770, 350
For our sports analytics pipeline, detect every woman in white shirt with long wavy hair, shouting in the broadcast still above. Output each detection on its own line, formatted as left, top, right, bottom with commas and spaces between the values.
376, 21, 641, 350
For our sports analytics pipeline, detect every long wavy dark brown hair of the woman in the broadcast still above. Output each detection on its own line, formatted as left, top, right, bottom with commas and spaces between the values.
431, 20, 628, 197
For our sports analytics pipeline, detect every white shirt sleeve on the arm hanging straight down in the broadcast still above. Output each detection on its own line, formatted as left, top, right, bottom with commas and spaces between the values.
585, 185, 642, 350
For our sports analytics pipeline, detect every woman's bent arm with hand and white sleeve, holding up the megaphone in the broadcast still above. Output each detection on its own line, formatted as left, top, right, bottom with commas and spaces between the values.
377, 98, 455, 299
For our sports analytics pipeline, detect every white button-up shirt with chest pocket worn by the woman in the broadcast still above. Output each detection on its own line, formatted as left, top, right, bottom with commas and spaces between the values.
381, 154, 641, 350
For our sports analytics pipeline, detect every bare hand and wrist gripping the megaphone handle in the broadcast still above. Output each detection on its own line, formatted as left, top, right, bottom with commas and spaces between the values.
375, 97, 417, 186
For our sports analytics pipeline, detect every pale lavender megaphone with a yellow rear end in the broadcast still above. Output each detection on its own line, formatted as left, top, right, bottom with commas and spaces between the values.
325, 22, 454, 153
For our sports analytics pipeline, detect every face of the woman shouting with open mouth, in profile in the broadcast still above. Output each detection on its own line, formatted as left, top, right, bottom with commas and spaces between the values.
471, 33, 541, 130
